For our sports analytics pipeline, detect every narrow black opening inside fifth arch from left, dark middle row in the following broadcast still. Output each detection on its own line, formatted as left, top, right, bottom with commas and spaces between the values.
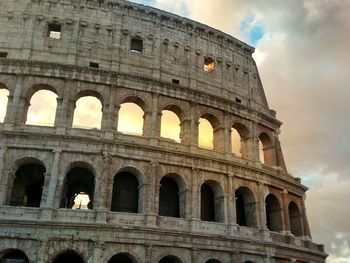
201, 183, 215, 221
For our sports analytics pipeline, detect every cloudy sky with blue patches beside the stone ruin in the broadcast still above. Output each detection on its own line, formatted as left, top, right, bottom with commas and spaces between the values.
0, 0, 350, 263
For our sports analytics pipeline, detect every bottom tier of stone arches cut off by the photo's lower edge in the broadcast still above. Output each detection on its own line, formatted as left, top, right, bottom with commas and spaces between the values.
0, 223, 327, 263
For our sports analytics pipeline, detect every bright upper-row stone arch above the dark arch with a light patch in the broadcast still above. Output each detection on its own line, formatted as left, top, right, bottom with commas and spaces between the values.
69, 89, 105, 129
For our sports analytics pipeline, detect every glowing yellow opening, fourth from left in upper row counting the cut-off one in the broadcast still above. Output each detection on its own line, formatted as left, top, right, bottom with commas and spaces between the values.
117, 102, 144, 136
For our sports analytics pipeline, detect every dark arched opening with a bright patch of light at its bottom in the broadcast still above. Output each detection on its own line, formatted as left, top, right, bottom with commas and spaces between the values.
60, 167, 95, 210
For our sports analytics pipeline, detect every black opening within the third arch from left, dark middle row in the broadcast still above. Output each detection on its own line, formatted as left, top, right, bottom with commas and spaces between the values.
111, 172, 139, 213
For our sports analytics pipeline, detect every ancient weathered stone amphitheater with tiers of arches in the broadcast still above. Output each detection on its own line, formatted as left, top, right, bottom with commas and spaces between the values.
0, 0, 326, 263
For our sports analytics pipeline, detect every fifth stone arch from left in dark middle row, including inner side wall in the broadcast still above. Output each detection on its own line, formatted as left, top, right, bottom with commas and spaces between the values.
200, 180, 225, 223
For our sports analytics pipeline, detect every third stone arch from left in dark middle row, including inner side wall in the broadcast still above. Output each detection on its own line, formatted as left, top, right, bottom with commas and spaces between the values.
111, 166, 145, 213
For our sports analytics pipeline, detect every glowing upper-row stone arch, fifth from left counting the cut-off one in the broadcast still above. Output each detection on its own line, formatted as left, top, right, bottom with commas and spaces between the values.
160, 104, 186, 142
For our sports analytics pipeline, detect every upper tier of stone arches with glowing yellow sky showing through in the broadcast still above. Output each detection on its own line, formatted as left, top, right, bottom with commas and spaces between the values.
0, 81, 285, 169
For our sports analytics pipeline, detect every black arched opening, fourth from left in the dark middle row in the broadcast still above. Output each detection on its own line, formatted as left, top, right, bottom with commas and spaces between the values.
159, 177, 180, 217
